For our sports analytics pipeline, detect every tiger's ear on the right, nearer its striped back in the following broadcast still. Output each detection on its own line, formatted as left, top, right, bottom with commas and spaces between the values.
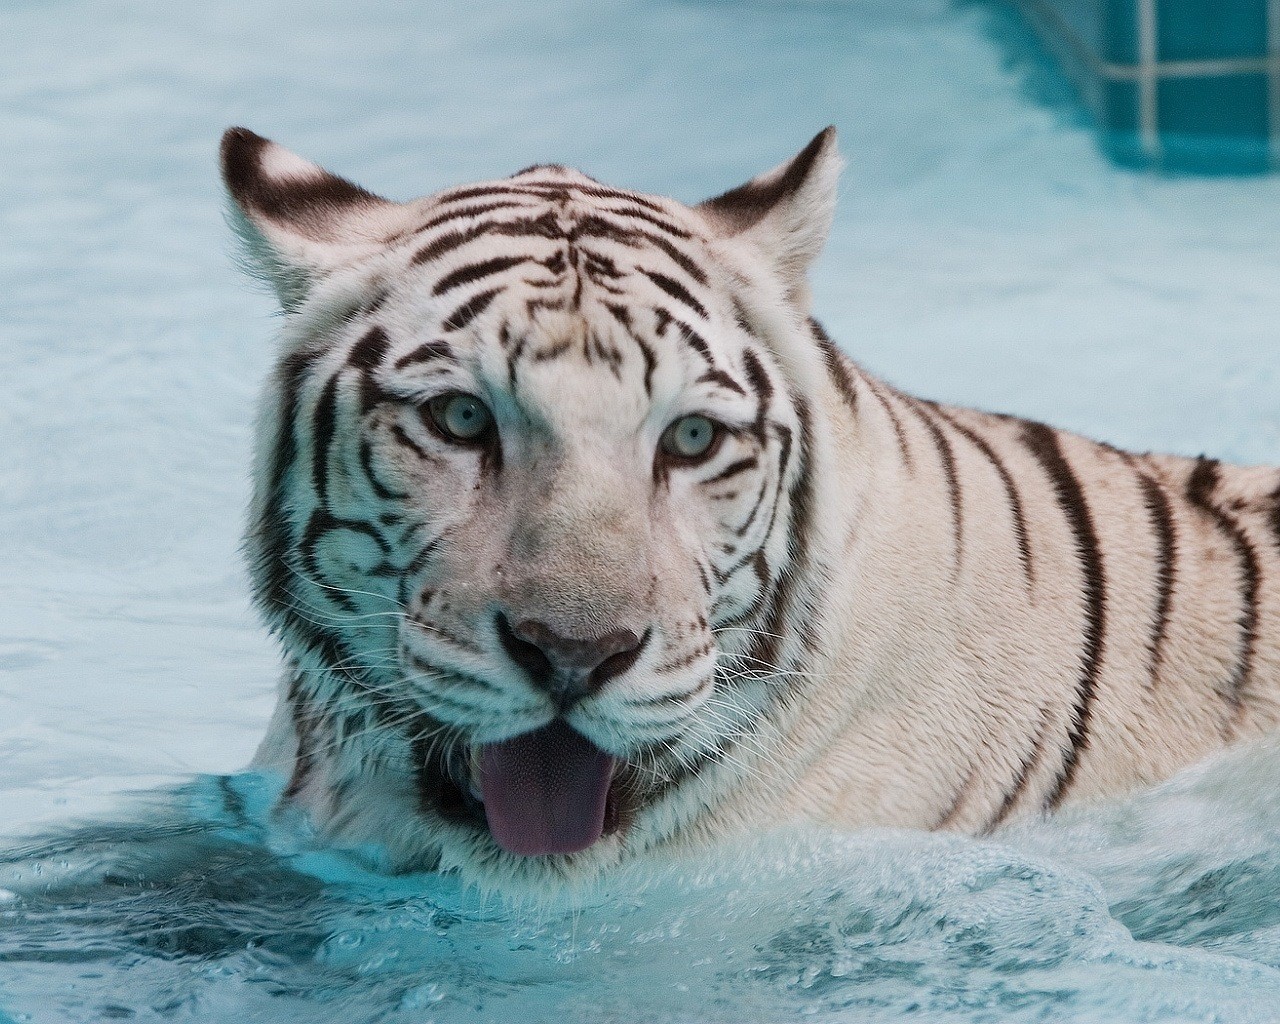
698, 125, 845, 305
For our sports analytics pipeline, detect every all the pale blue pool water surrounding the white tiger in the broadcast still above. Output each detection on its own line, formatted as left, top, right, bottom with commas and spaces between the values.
0, 0, 1280, 1024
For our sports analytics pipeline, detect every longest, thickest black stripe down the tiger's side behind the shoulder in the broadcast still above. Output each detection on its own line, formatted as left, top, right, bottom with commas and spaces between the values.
1021, 421, 1106, 810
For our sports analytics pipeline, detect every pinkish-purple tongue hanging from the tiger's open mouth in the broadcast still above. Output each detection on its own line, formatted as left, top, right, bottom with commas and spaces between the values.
480, 722, 613, 856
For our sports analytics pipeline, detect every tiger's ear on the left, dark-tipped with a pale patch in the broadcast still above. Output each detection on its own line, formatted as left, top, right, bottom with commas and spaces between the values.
221, 128, 403, 310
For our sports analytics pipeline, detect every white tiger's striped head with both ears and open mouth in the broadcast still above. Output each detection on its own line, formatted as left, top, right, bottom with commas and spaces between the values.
223, 129, 840, 869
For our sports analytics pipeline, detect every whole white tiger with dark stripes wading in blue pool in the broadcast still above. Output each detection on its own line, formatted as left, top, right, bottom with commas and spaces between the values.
221, 128, 1280, 887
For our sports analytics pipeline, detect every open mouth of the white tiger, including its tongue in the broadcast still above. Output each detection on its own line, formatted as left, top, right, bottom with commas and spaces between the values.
422, 721, 639, 856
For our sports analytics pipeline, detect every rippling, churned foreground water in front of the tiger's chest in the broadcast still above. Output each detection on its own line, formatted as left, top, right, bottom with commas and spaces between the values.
0, 742, 1280, 1024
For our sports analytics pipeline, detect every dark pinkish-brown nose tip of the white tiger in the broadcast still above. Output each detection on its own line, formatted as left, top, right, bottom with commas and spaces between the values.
498, 613, 649, 708
